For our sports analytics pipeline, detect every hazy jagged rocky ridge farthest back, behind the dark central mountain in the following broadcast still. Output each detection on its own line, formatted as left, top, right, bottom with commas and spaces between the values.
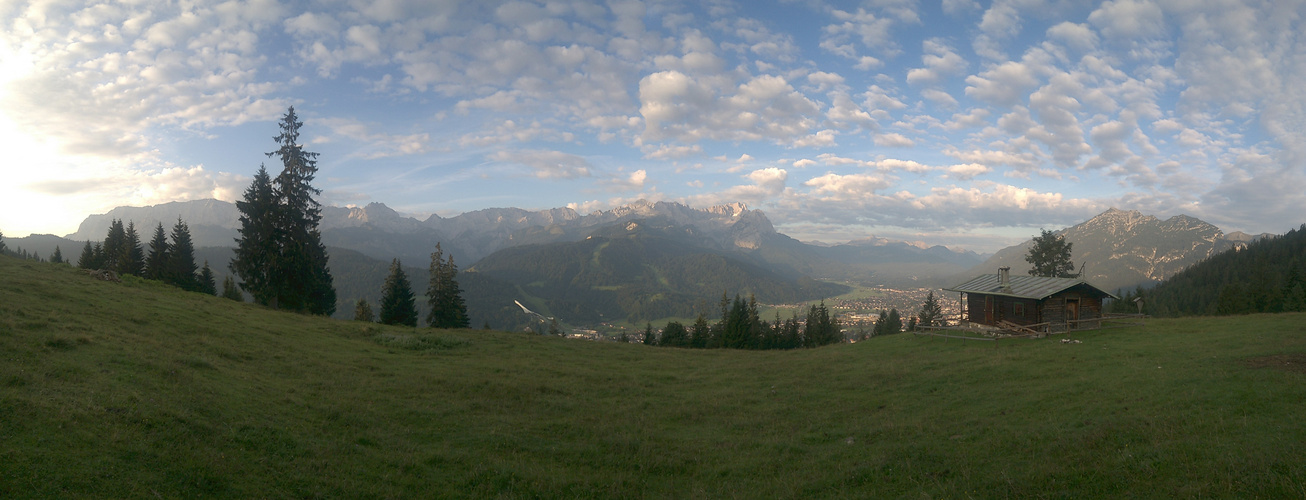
65, 200, 978, 286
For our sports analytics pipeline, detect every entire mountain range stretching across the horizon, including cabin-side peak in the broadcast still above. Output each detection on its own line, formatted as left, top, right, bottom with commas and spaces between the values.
10, 200, 1263, 328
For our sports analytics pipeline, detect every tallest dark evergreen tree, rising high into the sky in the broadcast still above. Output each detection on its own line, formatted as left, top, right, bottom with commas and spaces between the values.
268, 107, 336, 316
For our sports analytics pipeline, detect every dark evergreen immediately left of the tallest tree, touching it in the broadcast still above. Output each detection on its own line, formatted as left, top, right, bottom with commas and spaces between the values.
230, 164, 281, 305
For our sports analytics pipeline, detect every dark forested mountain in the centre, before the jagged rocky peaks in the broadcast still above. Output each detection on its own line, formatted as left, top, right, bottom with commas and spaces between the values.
469, 219, 844, 322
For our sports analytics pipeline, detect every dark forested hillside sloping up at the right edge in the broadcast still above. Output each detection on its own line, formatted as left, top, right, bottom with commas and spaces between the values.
1122, 225, 1306, 316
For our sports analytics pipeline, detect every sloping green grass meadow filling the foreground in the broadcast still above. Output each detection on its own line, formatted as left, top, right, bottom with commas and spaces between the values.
0, 258, 1306, 499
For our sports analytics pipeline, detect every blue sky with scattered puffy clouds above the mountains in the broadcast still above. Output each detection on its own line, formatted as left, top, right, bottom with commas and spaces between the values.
0, 0, 1306, 252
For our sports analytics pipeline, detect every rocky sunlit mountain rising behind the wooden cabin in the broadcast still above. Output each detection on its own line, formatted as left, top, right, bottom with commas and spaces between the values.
956, 209, 1250, 291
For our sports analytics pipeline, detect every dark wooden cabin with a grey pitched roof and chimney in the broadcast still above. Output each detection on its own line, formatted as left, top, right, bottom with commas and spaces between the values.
944, 268, 1119, 333
